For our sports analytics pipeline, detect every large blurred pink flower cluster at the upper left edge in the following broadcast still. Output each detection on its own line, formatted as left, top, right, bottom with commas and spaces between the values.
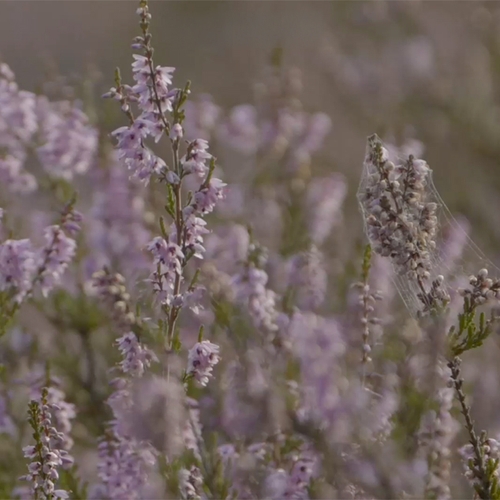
0, 63, 98, 193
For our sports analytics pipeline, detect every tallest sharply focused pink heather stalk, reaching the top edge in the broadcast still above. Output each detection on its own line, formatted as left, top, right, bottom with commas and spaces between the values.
105, 1, 225, 376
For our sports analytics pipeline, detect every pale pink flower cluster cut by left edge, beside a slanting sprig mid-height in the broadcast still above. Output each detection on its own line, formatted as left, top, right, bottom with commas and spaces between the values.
0, 239, 36, 302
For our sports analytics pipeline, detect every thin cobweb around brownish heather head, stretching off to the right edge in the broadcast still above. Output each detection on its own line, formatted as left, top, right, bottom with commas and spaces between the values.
357, 136, 500, 317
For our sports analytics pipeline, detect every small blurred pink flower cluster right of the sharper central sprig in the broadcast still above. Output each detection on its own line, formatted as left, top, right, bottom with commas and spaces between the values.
288, 246, 327, 310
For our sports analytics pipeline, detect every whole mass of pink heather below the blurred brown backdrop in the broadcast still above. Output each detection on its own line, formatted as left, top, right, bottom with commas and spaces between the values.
0, 0, 500, 500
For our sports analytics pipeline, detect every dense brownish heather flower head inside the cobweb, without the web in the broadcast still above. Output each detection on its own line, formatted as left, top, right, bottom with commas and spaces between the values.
358, 136, 449, 312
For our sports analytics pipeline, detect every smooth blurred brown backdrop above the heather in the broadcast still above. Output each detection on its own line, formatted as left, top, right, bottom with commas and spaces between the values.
0, 0, 500, 254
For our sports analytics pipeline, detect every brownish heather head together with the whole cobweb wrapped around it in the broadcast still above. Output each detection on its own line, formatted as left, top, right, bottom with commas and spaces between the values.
357, 135, 500, 317
